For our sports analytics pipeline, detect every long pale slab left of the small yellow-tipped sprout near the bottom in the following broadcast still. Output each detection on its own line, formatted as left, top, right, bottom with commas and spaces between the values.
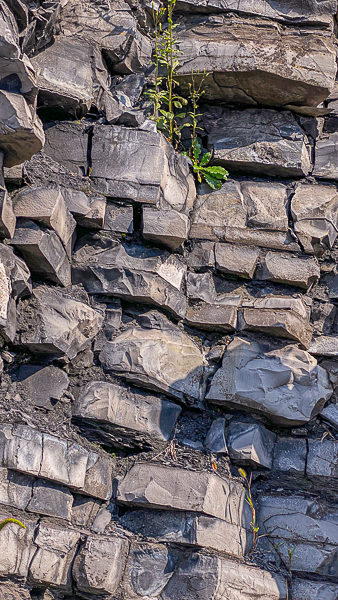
116, 463, 249, 527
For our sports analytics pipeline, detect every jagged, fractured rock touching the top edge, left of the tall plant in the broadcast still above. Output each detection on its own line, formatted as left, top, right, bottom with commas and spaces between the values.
61, 0, 152, 74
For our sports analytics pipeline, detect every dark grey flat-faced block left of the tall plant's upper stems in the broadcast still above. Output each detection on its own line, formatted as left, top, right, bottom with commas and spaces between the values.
32, 36, 94, 118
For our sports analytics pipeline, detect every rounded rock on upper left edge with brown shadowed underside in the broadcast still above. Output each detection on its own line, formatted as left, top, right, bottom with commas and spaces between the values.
0, 89, 45, 167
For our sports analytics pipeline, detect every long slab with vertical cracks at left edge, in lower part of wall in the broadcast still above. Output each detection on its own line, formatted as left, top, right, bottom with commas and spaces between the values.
0, 425, 112, 500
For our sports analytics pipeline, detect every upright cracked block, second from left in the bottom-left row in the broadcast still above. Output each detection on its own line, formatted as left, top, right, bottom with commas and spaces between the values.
29, 521, 81, 590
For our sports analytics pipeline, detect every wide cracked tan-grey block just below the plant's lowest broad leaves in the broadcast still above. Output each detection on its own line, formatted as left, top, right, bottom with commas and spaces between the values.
189, 179, 313, 253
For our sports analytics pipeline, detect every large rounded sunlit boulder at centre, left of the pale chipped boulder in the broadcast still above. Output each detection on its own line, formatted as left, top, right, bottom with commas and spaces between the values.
100, 311, 206, 402
